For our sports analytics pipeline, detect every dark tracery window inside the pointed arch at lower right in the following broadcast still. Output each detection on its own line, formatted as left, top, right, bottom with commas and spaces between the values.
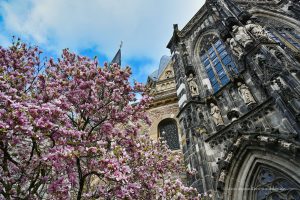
254, 167, 300, 200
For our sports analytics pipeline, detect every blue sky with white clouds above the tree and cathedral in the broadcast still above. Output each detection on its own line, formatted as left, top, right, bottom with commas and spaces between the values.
0, 0, 204, 83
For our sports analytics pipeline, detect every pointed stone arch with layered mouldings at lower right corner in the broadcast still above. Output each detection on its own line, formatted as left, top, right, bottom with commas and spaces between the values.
217, 137, 300, 200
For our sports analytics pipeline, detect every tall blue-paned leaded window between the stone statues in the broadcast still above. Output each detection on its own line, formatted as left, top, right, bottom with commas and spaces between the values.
201, 40, 238, 92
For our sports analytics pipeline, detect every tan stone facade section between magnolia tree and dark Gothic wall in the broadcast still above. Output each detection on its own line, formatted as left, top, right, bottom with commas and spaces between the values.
147, 56, 181, 150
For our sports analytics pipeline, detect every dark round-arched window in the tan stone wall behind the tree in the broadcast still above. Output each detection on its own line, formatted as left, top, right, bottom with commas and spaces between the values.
158, 119, 180, 150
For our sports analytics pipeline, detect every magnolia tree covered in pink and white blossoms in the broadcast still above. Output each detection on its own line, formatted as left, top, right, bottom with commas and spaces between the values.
0, 41, 198, 199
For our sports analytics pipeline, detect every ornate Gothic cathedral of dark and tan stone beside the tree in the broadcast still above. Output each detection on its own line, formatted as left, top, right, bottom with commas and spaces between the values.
147, 0, 300, 200
